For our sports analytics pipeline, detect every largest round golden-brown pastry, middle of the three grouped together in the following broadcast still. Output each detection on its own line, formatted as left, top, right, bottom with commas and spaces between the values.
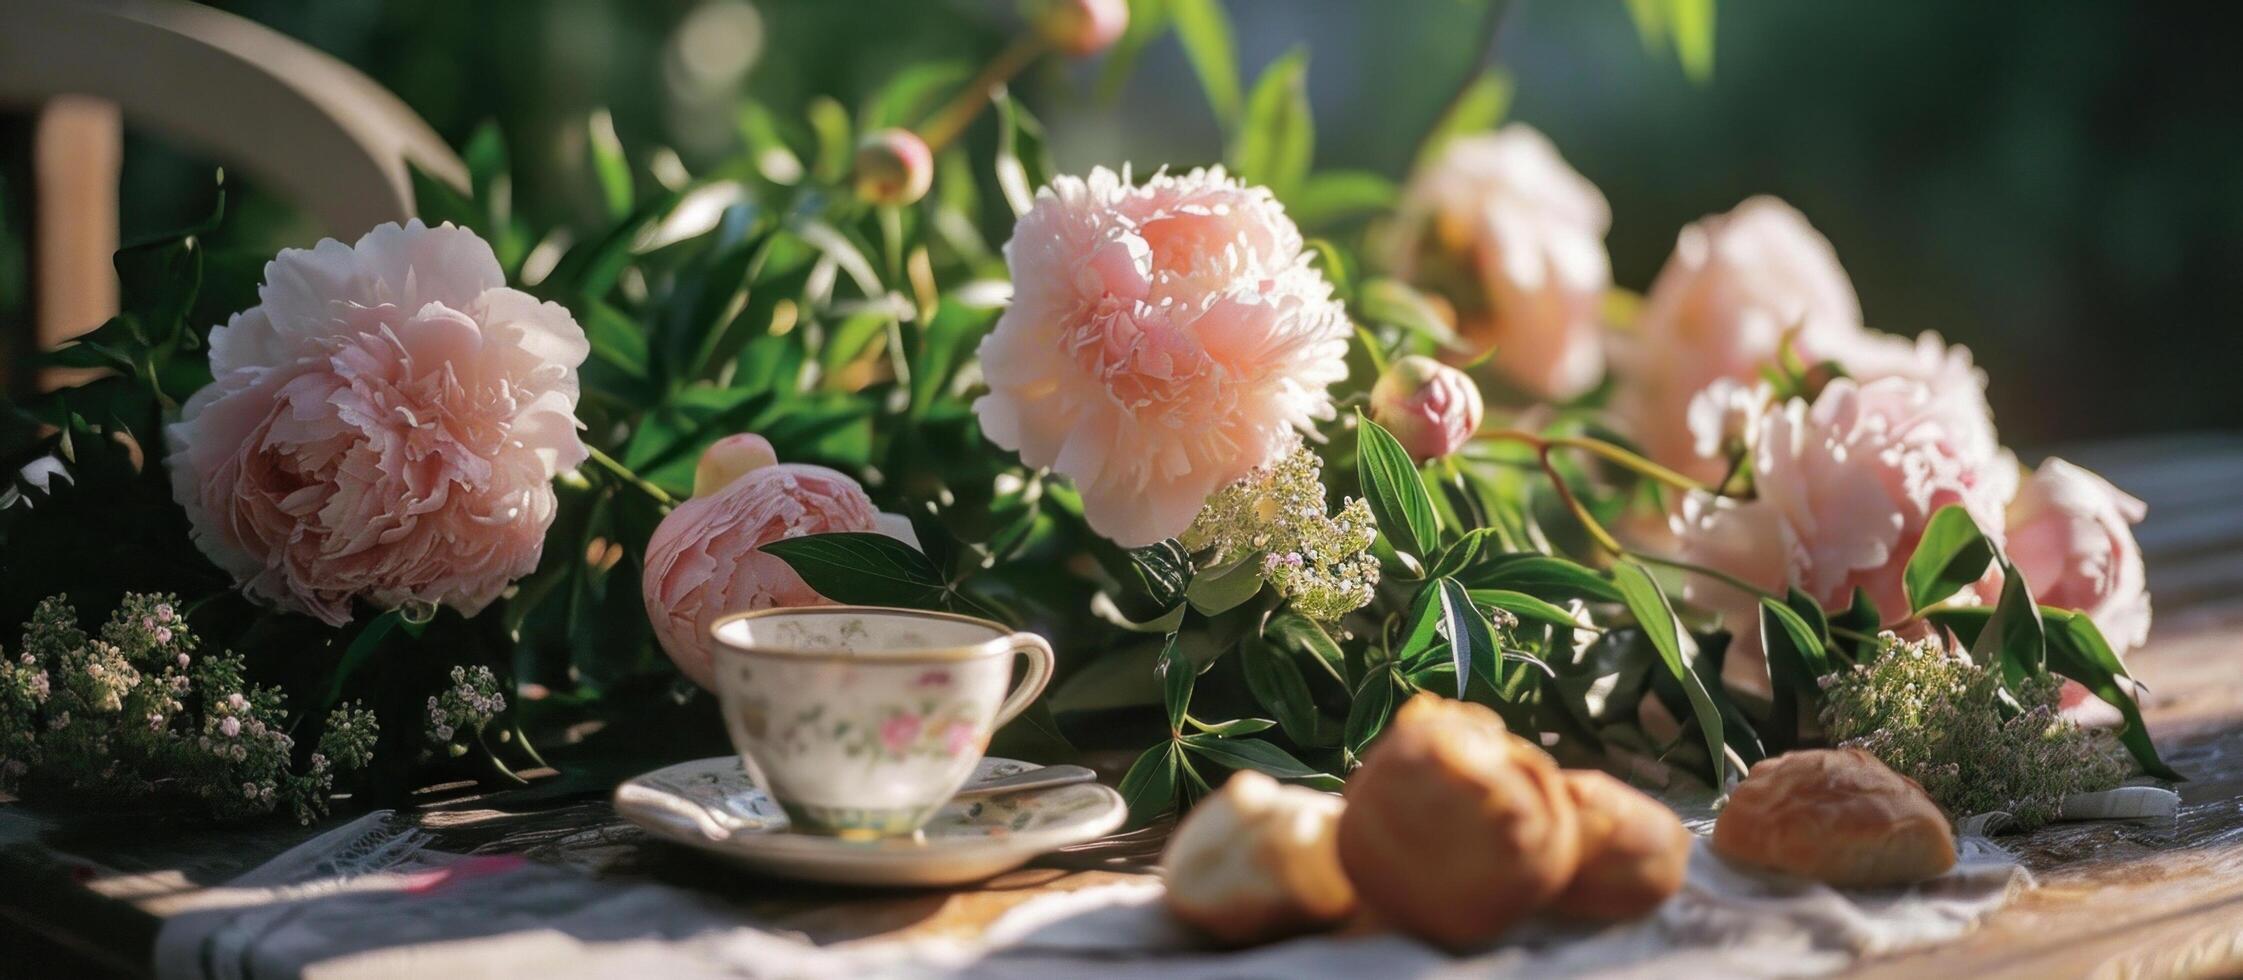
1339, 695, 1579, 949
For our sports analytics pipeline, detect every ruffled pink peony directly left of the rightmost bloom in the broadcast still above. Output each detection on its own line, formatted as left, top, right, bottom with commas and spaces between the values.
1673, 377, 2016, 688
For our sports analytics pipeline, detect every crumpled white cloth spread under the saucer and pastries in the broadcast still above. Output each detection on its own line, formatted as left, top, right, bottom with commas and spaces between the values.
155, 812, 2032, 980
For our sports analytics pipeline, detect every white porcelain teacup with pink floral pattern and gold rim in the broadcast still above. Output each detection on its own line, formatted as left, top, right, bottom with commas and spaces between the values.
711, 605, 1052, 839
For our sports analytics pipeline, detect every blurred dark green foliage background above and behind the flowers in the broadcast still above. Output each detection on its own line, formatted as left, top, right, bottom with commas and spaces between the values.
0, 0, 2243, 446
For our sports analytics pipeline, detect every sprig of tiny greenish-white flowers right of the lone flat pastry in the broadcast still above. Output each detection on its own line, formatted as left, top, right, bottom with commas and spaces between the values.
1821, 632, 2126, 830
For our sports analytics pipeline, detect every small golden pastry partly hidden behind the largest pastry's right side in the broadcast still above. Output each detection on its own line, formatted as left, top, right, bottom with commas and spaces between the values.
1550, 769, 1693, 919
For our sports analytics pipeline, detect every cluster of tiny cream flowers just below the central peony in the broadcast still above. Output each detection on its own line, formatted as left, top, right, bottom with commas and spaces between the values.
1180, 446, 1379, 623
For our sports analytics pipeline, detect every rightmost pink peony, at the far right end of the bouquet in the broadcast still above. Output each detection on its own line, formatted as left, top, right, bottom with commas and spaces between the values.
2007, 460, 2149, 653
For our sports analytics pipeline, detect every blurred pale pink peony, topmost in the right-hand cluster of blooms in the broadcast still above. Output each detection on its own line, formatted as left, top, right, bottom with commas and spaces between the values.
1613, 197, 1862, 482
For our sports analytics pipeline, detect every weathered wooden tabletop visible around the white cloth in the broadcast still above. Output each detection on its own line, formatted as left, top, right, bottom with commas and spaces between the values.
13, 435, 2243, 978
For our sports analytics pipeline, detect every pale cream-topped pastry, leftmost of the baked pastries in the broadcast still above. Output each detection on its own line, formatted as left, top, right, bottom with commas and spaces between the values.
1160, 771, 1355, 946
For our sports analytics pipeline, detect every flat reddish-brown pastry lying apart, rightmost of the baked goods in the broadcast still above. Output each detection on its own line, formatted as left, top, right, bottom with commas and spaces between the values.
1714, 749, 1956, 888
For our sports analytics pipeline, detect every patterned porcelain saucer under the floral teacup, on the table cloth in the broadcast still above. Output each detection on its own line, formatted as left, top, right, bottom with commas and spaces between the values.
615, 756, 1128, 886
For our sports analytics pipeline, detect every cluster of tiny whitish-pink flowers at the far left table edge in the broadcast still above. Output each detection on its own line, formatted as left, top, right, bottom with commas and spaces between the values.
0, 594, 377, 823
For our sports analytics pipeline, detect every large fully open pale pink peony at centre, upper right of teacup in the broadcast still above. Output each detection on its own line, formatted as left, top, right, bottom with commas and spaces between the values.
973, 168, 1350, 547
